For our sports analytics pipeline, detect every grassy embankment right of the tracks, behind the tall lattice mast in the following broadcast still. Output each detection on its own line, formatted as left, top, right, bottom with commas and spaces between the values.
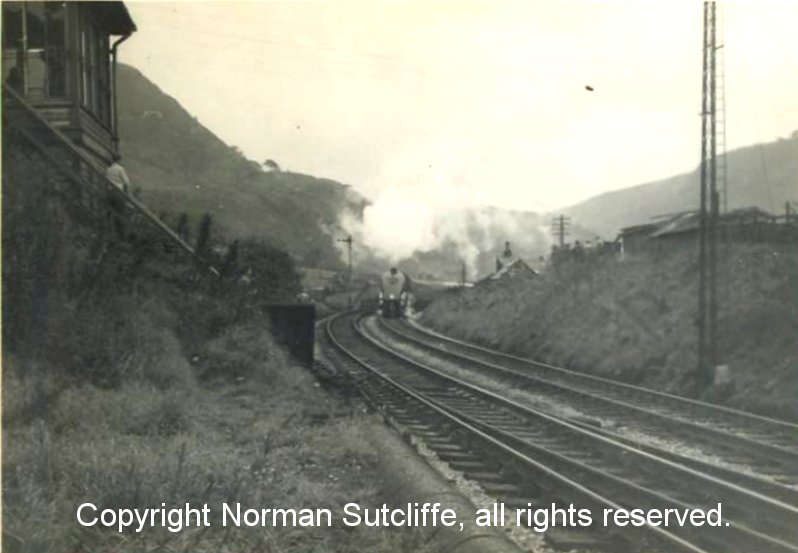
422, 244, 798, 420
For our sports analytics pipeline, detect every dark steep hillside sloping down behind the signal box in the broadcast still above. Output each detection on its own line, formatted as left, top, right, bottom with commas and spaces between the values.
118, 64, 365, 268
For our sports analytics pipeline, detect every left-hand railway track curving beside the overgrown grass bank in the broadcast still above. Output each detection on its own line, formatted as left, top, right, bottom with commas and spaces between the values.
326, 314, 798, 553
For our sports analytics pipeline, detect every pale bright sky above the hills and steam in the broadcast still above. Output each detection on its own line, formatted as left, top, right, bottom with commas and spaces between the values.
120, 0, 798, 218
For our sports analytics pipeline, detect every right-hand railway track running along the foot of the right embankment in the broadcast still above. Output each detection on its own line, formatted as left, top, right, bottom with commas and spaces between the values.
380, 314, 798, 484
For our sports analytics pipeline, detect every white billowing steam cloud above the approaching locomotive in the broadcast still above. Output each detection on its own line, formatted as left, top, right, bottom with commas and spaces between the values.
332, 139, 550, 278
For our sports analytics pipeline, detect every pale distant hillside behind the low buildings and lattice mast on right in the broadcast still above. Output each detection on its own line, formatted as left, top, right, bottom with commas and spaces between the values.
563, 131, 798, 239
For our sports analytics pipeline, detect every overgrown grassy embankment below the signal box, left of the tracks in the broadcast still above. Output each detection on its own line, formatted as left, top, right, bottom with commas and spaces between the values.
2, 144, 428, 553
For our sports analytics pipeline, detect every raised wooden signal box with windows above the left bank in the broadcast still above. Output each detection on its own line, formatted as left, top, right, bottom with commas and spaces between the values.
2, 2, 136, 165
